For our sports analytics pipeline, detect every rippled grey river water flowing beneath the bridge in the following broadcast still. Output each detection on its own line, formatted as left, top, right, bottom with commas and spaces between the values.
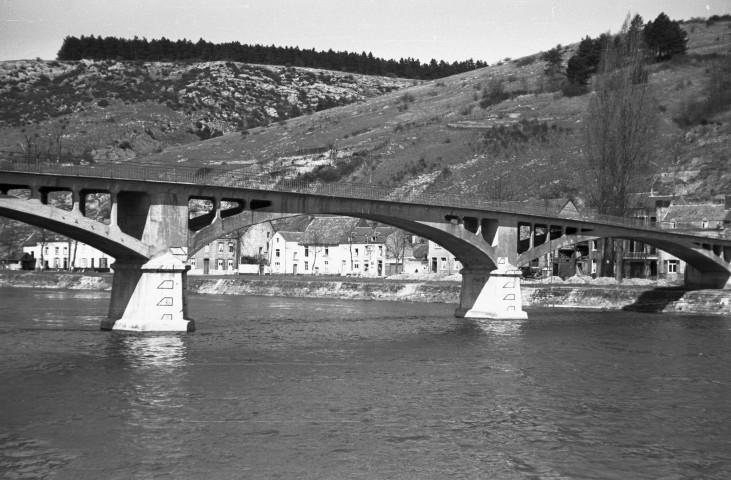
0, 289, 731, 480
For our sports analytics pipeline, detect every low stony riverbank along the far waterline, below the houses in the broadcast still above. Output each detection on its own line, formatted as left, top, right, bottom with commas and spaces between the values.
0, 271, 731, 315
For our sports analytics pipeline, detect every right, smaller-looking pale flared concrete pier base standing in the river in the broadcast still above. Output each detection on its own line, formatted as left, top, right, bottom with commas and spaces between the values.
454, 258, 528, 320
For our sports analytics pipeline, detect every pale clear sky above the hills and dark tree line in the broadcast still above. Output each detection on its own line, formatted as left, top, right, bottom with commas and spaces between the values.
0, 0, 731, 64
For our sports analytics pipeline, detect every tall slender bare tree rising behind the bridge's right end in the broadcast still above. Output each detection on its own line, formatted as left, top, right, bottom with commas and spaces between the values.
585, 15, 657, 280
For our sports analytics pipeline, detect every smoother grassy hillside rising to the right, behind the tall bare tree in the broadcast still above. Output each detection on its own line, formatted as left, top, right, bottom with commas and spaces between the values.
142, 21, 731, 200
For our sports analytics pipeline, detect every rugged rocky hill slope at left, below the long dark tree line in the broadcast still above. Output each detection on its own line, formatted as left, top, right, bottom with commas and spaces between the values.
0, 60, 411, 161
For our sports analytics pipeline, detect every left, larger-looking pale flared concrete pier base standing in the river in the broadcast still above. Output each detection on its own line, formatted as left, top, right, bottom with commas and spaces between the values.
101, 253, 195, 332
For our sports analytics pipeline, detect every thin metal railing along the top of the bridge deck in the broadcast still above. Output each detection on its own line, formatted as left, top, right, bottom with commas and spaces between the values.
0, 152, 728, 235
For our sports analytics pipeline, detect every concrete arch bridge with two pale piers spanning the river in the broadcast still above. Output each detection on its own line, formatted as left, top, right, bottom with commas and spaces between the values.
0, 160, 731, 331
